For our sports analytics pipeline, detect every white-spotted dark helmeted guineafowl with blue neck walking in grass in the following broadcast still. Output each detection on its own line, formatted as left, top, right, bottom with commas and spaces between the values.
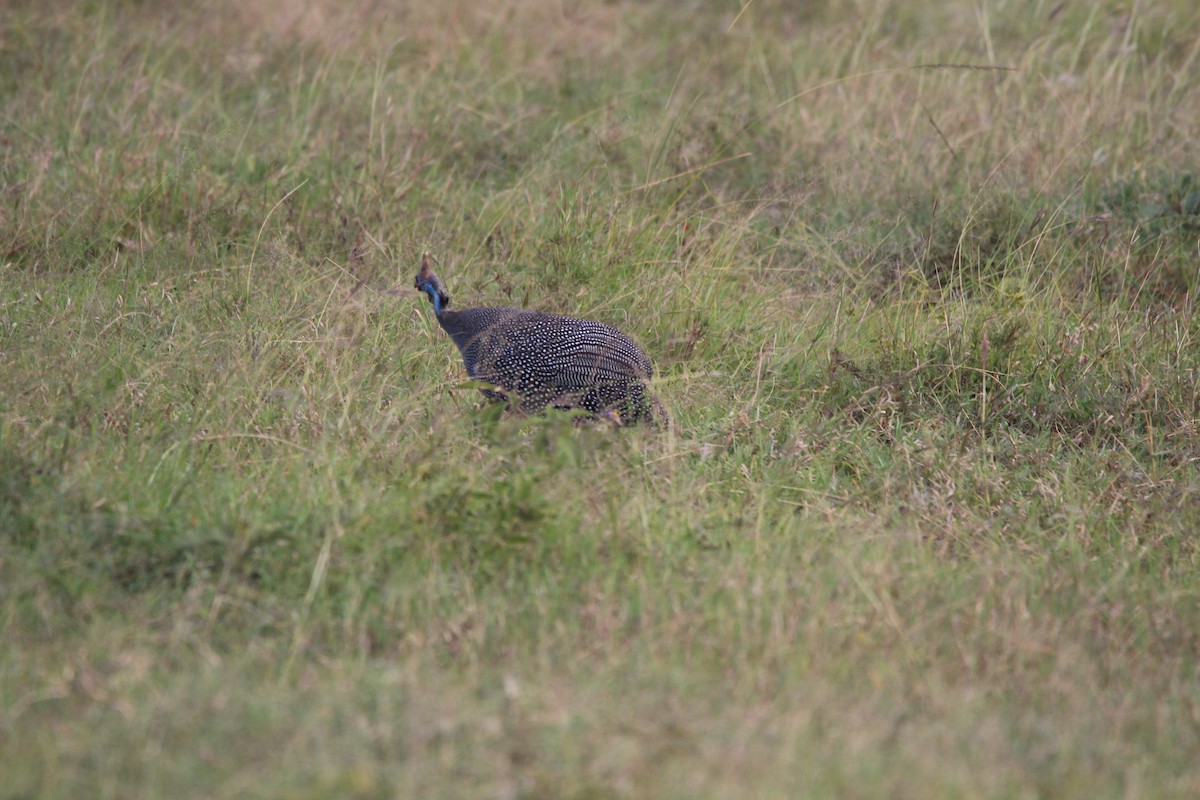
414, 253, 668, 425
